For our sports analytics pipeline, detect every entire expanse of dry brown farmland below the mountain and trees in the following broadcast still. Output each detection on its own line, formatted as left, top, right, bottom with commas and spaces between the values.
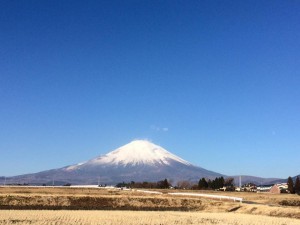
0, 187, 300, 225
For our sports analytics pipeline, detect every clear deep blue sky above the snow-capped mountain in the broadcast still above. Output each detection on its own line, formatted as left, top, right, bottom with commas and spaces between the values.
0, 0, 300, 178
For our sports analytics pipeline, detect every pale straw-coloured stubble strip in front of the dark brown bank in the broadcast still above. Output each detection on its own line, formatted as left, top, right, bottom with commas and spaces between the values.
0, 210, 299, 225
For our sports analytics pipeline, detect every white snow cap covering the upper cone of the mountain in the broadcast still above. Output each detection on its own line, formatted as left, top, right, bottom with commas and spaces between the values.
83, 140, 191, 166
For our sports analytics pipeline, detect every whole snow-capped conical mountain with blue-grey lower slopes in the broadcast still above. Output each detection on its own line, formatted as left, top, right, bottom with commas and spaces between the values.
8, 140, 222, 184
